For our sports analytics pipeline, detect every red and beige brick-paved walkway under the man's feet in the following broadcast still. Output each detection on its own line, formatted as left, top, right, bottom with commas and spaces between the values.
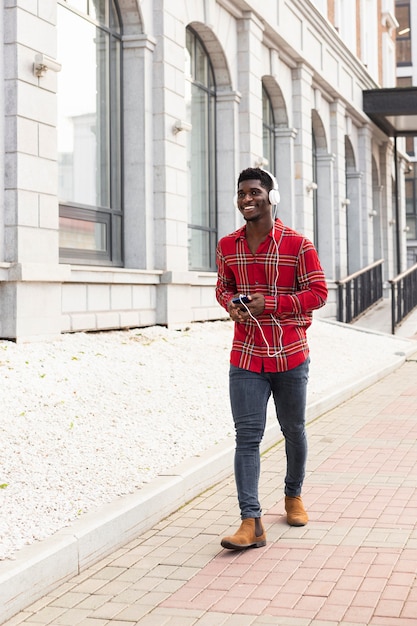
5, 354, 417, 626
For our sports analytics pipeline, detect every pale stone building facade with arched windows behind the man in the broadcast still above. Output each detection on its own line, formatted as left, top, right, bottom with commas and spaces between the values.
0, 0, 407, 341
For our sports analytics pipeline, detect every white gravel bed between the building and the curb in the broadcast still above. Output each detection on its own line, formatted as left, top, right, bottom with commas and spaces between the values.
0, 319, 417, 559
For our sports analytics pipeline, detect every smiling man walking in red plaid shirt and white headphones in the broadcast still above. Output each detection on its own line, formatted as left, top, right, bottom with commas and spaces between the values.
216, 168, 327, 550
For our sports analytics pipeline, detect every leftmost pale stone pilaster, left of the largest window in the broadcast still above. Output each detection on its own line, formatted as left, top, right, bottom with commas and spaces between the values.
0, 0, 66, 341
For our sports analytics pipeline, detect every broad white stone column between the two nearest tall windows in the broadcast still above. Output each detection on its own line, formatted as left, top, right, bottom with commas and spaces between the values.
152, 0, 190, 272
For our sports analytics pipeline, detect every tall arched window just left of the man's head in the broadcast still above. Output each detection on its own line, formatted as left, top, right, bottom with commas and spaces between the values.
186, 28, 217, 271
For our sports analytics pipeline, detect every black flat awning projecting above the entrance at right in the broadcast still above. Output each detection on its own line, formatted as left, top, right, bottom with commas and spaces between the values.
363, 87, 417, 137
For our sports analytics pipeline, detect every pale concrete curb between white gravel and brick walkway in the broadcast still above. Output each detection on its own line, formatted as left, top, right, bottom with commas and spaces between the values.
0, 345, 416, 623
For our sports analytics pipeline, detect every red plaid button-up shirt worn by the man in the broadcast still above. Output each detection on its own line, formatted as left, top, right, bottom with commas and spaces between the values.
216, 219, 327, 372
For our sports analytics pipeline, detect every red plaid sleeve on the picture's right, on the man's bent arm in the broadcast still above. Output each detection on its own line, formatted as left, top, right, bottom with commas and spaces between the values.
265, 239, 328, 316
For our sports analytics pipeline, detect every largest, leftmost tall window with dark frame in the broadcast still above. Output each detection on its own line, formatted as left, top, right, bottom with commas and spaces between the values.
57, 0, 122, 266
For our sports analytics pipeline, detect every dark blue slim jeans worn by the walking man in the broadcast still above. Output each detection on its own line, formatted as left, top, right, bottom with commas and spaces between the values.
229, 358, 310, 519
